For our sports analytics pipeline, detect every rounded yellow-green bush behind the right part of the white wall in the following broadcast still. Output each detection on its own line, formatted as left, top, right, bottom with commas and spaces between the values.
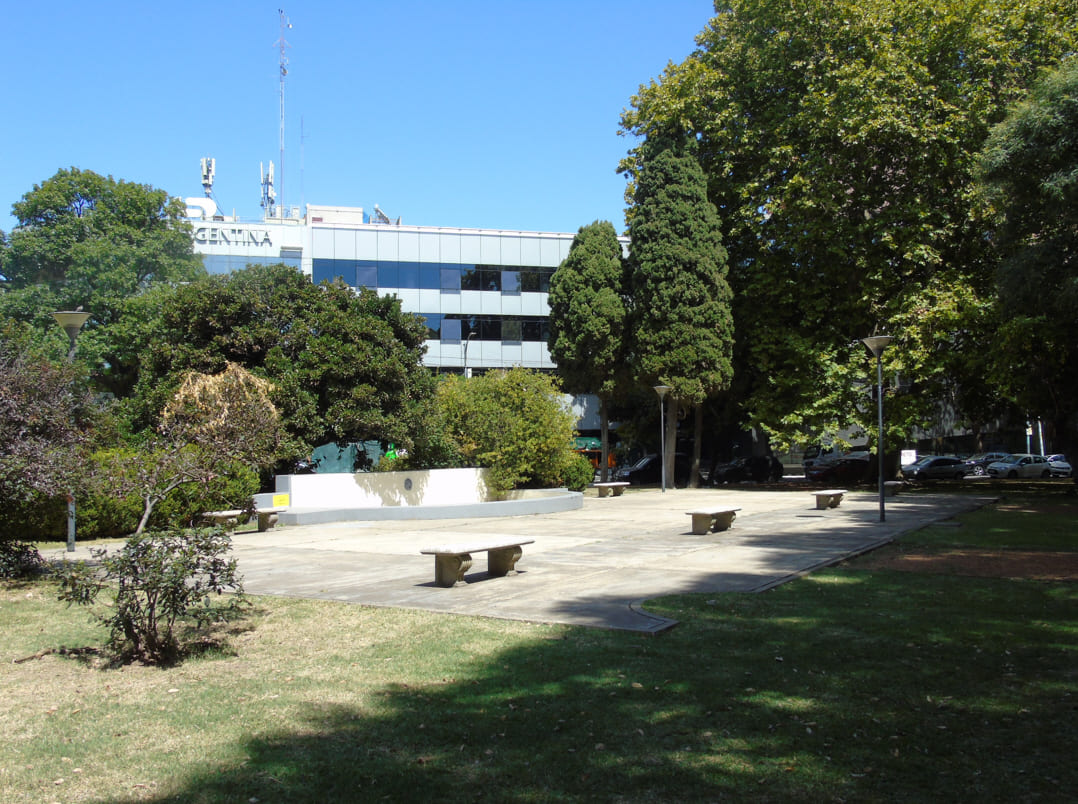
438, 368, 575, 493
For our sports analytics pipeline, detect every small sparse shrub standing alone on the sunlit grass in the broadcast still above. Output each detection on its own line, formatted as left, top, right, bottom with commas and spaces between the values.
59, 528, 246, 664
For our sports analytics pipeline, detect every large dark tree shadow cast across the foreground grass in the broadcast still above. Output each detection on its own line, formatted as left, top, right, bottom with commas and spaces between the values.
130, 570, 1078, 802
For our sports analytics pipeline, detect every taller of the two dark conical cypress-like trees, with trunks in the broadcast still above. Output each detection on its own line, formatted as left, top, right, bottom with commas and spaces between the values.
628, 138, 733, 485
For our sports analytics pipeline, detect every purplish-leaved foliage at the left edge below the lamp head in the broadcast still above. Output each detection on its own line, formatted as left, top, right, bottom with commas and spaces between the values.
0, 321, 91, 540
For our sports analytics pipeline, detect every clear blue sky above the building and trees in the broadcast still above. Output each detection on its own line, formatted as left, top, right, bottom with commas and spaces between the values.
0, 0, 713, 232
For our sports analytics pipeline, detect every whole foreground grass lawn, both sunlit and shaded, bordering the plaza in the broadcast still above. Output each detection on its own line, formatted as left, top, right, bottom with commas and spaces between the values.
0, 496, 1078, 803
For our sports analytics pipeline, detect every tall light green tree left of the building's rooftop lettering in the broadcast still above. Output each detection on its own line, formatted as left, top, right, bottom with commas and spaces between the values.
0, 167, 206, 385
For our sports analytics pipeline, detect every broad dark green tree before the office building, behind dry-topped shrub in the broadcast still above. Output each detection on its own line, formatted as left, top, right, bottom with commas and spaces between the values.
133, 265, 434, 459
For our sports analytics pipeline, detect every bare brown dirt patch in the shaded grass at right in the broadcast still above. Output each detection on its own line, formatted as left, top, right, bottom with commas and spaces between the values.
846, 544, 1078, 581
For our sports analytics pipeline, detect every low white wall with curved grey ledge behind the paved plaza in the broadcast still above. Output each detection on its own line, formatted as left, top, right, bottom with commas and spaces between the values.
268, 469, 583, 525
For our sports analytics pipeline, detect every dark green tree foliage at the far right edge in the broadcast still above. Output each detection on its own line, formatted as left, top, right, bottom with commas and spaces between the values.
981, 58, 1078, 447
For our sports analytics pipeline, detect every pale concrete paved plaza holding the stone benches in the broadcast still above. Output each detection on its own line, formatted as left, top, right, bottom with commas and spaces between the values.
220, 489, 990, 633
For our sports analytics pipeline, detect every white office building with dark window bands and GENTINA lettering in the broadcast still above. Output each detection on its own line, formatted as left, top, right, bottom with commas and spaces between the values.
187, 214, 590, 371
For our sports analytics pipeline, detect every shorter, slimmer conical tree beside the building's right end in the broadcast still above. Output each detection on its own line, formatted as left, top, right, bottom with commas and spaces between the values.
548, 221, 627, 481
